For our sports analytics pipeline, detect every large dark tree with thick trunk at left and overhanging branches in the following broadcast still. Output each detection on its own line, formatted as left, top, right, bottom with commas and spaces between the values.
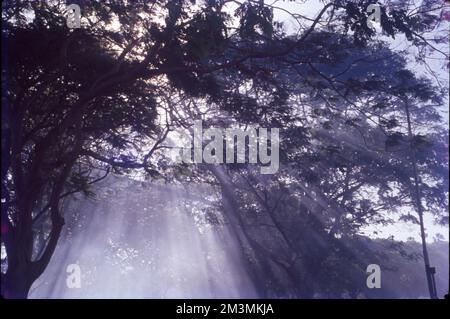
1, 0, 446, 298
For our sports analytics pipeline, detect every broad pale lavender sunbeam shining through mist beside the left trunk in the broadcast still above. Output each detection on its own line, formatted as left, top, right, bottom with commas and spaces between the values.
30, 180, 256, 298
